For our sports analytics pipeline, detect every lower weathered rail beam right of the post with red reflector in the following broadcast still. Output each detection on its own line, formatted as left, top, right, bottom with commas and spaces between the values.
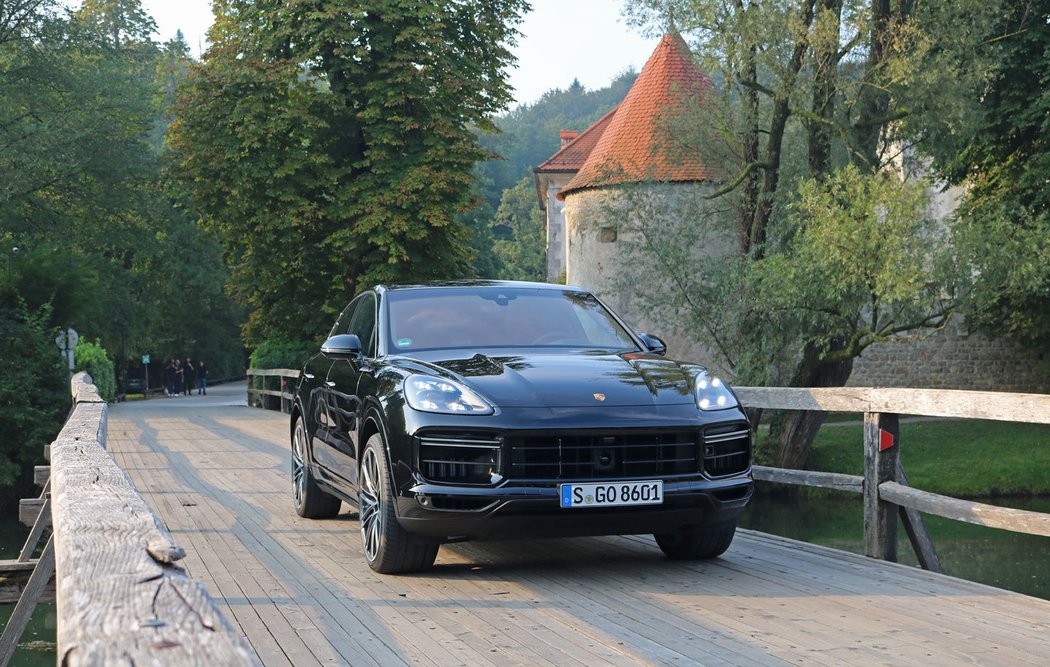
879, 482, 1050, 537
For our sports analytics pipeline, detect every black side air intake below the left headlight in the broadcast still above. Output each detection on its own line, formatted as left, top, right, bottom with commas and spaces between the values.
418, 433, 503, 484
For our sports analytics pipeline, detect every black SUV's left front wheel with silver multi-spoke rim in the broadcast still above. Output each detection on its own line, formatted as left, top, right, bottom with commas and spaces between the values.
357, 433, 439, 575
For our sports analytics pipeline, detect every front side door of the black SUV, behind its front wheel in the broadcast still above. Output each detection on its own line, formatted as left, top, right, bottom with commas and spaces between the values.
326, 292, 377, 484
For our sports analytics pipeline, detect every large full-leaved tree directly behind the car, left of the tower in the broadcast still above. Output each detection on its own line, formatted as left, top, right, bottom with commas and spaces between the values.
172, 0, 527, 341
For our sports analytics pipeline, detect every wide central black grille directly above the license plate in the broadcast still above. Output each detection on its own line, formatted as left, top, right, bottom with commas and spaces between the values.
508, 431, 699, 481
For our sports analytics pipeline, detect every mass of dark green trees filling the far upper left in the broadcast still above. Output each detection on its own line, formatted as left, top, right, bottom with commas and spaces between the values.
0, 1, 243, 390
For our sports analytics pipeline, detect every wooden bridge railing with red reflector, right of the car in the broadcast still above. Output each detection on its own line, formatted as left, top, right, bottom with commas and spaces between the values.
736, 387, 1050, 571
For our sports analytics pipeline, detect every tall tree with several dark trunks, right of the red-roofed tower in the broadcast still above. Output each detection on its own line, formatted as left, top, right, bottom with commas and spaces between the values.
613, 0, 999, 467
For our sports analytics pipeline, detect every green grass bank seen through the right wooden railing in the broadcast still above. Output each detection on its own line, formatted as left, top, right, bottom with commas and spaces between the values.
809, 419, 1050, 498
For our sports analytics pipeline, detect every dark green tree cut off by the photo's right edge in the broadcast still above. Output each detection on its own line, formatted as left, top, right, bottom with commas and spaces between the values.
937, 0, 1050, 349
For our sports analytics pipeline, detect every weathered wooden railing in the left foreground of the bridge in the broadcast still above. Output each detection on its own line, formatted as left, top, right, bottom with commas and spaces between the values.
0, 373, 259, 665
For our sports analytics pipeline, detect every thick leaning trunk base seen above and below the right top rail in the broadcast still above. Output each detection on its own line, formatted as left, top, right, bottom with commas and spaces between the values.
777, 340, 853, 470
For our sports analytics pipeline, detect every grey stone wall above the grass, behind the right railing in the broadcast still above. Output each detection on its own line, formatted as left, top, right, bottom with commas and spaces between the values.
849, 317, 1050, 394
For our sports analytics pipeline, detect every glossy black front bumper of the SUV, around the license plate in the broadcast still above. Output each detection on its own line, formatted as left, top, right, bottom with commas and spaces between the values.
392, 403, 753, 541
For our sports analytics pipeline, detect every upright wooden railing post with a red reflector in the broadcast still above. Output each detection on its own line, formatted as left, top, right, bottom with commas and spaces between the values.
864, 412, 900, 562
